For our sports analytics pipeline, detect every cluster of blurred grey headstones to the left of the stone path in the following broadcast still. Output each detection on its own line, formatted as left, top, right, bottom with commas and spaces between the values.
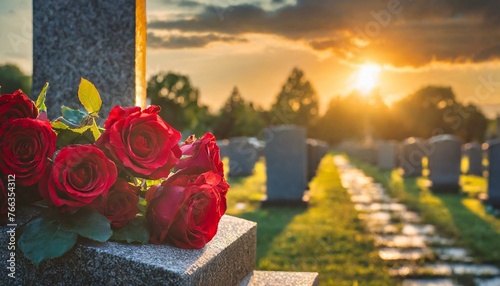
218, 125, 329, 204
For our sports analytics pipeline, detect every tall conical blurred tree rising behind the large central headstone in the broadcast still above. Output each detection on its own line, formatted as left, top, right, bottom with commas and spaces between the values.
271, 68, 319, 131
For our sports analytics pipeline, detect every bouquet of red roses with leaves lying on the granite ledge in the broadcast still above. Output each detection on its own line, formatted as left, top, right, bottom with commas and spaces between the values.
0, 79, 229, 265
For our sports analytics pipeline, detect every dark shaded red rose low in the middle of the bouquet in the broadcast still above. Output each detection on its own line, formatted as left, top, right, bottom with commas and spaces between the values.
99, 178, 140, 228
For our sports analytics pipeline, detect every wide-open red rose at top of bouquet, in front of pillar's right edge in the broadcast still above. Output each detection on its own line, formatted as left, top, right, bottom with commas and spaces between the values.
96, 106, 181, 180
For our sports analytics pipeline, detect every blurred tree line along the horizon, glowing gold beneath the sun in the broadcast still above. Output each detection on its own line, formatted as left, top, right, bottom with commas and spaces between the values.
0, 65, 488, 144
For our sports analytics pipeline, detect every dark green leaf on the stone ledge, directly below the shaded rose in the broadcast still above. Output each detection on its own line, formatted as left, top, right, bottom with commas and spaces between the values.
63, 208, 113, 242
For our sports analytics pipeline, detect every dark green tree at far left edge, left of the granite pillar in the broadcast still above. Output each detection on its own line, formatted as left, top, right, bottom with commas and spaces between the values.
0, 64, 31, 98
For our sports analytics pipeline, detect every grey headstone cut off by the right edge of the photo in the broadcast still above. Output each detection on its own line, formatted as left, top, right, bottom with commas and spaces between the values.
485, 139, 500, 209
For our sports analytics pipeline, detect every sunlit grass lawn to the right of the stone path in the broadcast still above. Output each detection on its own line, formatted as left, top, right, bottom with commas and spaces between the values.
353, 156, 500, 266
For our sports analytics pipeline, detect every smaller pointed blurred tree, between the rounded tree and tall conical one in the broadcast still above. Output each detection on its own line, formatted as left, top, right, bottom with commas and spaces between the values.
214, 87, 264, 139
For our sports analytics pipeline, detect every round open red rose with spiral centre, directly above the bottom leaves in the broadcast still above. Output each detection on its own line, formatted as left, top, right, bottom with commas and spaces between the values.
39, 145, 117, 211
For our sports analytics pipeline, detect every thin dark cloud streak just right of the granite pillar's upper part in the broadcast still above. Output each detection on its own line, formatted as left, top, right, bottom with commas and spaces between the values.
147, 33, 246, 49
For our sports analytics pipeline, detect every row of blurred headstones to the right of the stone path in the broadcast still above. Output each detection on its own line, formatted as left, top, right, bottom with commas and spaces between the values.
341, 134, 500, 208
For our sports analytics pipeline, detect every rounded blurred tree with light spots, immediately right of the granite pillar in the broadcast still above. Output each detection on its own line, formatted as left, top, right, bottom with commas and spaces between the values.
147, 72, 212, 136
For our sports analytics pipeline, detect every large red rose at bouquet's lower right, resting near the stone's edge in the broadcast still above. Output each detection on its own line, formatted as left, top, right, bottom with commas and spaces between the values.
146, 171, 229, 249
